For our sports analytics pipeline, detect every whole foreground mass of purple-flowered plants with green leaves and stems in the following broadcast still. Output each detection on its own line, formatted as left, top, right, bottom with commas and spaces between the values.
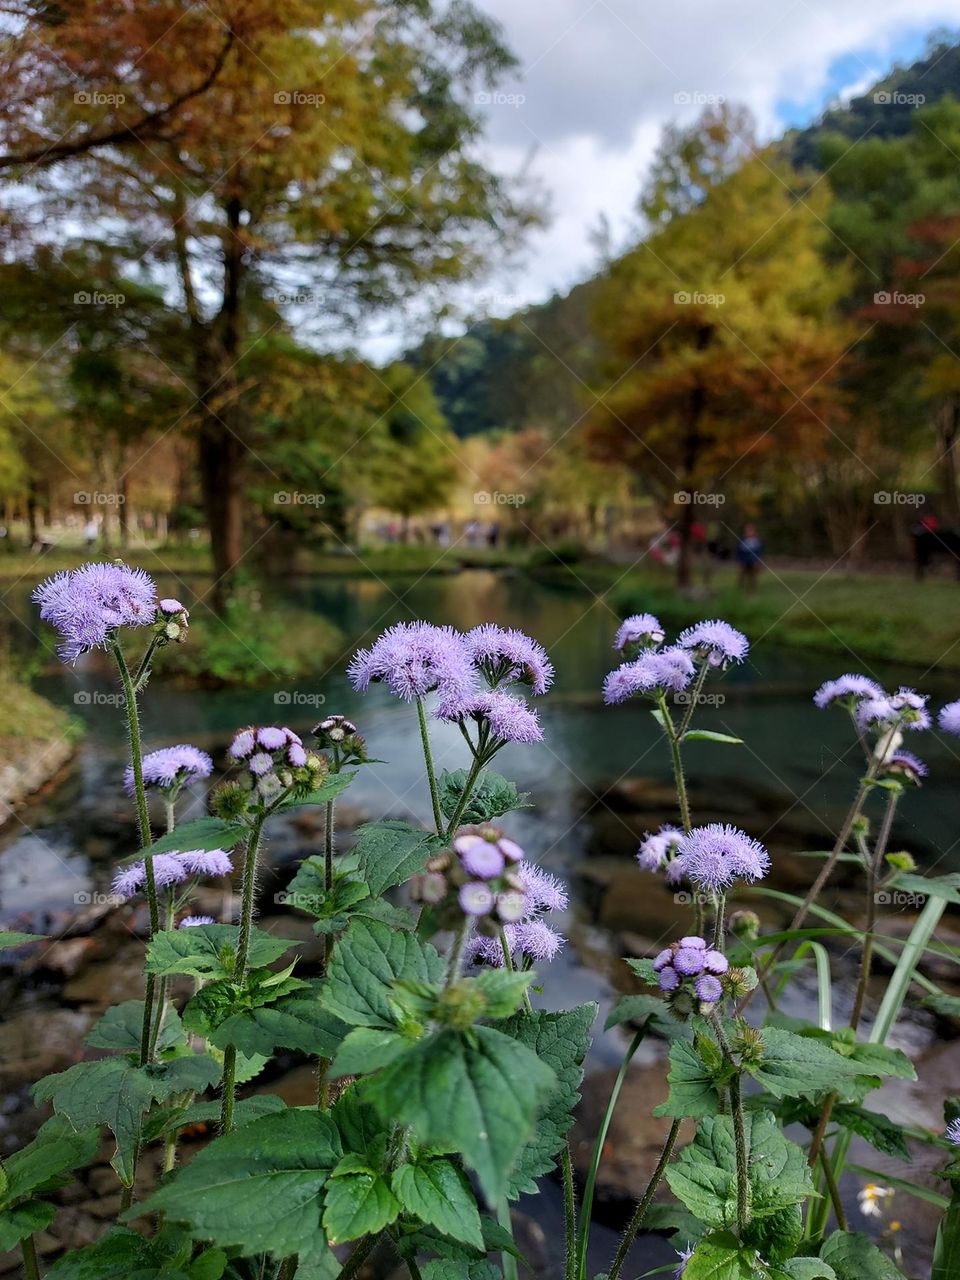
0, 578, 960, 1280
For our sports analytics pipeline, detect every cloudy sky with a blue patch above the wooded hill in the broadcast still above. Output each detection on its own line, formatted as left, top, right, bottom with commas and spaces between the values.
394, 0, 960, 340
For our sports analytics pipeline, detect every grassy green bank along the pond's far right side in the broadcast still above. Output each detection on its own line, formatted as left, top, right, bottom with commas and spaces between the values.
531, 561, 960, 671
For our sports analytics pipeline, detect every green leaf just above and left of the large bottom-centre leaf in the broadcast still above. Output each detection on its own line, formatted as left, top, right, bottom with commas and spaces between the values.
324, 920, 444, 1028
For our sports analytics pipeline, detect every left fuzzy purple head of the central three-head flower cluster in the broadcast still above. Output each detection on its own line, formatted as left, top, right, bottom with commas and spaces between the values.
347, 622, 476, 703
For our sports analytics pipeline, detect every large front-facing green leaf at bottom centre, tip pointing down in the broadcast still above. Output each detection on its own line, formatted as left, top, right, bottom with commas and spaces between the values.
369, 1027, 557, 1201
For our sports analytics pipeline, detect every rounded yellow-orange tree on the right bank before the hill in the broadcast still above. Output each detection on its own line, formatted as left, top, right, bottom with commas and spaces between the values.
588, 113, 850, 586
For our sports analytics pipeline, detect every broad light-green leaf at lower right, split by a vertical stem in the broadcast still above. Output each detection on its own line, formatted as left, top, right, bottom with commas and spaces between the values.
667, 1111, 814, 1230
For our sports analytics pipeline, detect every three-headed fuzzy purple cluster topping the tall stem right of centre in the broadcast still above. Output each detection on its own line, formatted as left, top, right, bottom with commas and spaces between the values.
603, 613, 750, 704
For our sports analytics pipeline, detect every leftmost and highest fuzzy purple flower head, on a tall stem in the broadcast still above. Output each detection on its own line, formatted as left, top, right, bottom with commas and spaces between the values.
33, 563, 157, 662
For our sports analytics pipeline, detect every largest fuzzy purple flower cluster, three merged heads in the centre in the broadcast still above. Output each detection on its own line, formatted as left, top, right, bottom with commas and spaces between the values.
347, 622, 553, 749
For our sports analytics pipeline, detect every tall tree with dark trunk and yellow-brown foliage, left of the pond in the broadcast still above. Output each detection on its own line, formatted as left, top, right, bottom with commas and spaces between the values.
16, 0, 530, 599
